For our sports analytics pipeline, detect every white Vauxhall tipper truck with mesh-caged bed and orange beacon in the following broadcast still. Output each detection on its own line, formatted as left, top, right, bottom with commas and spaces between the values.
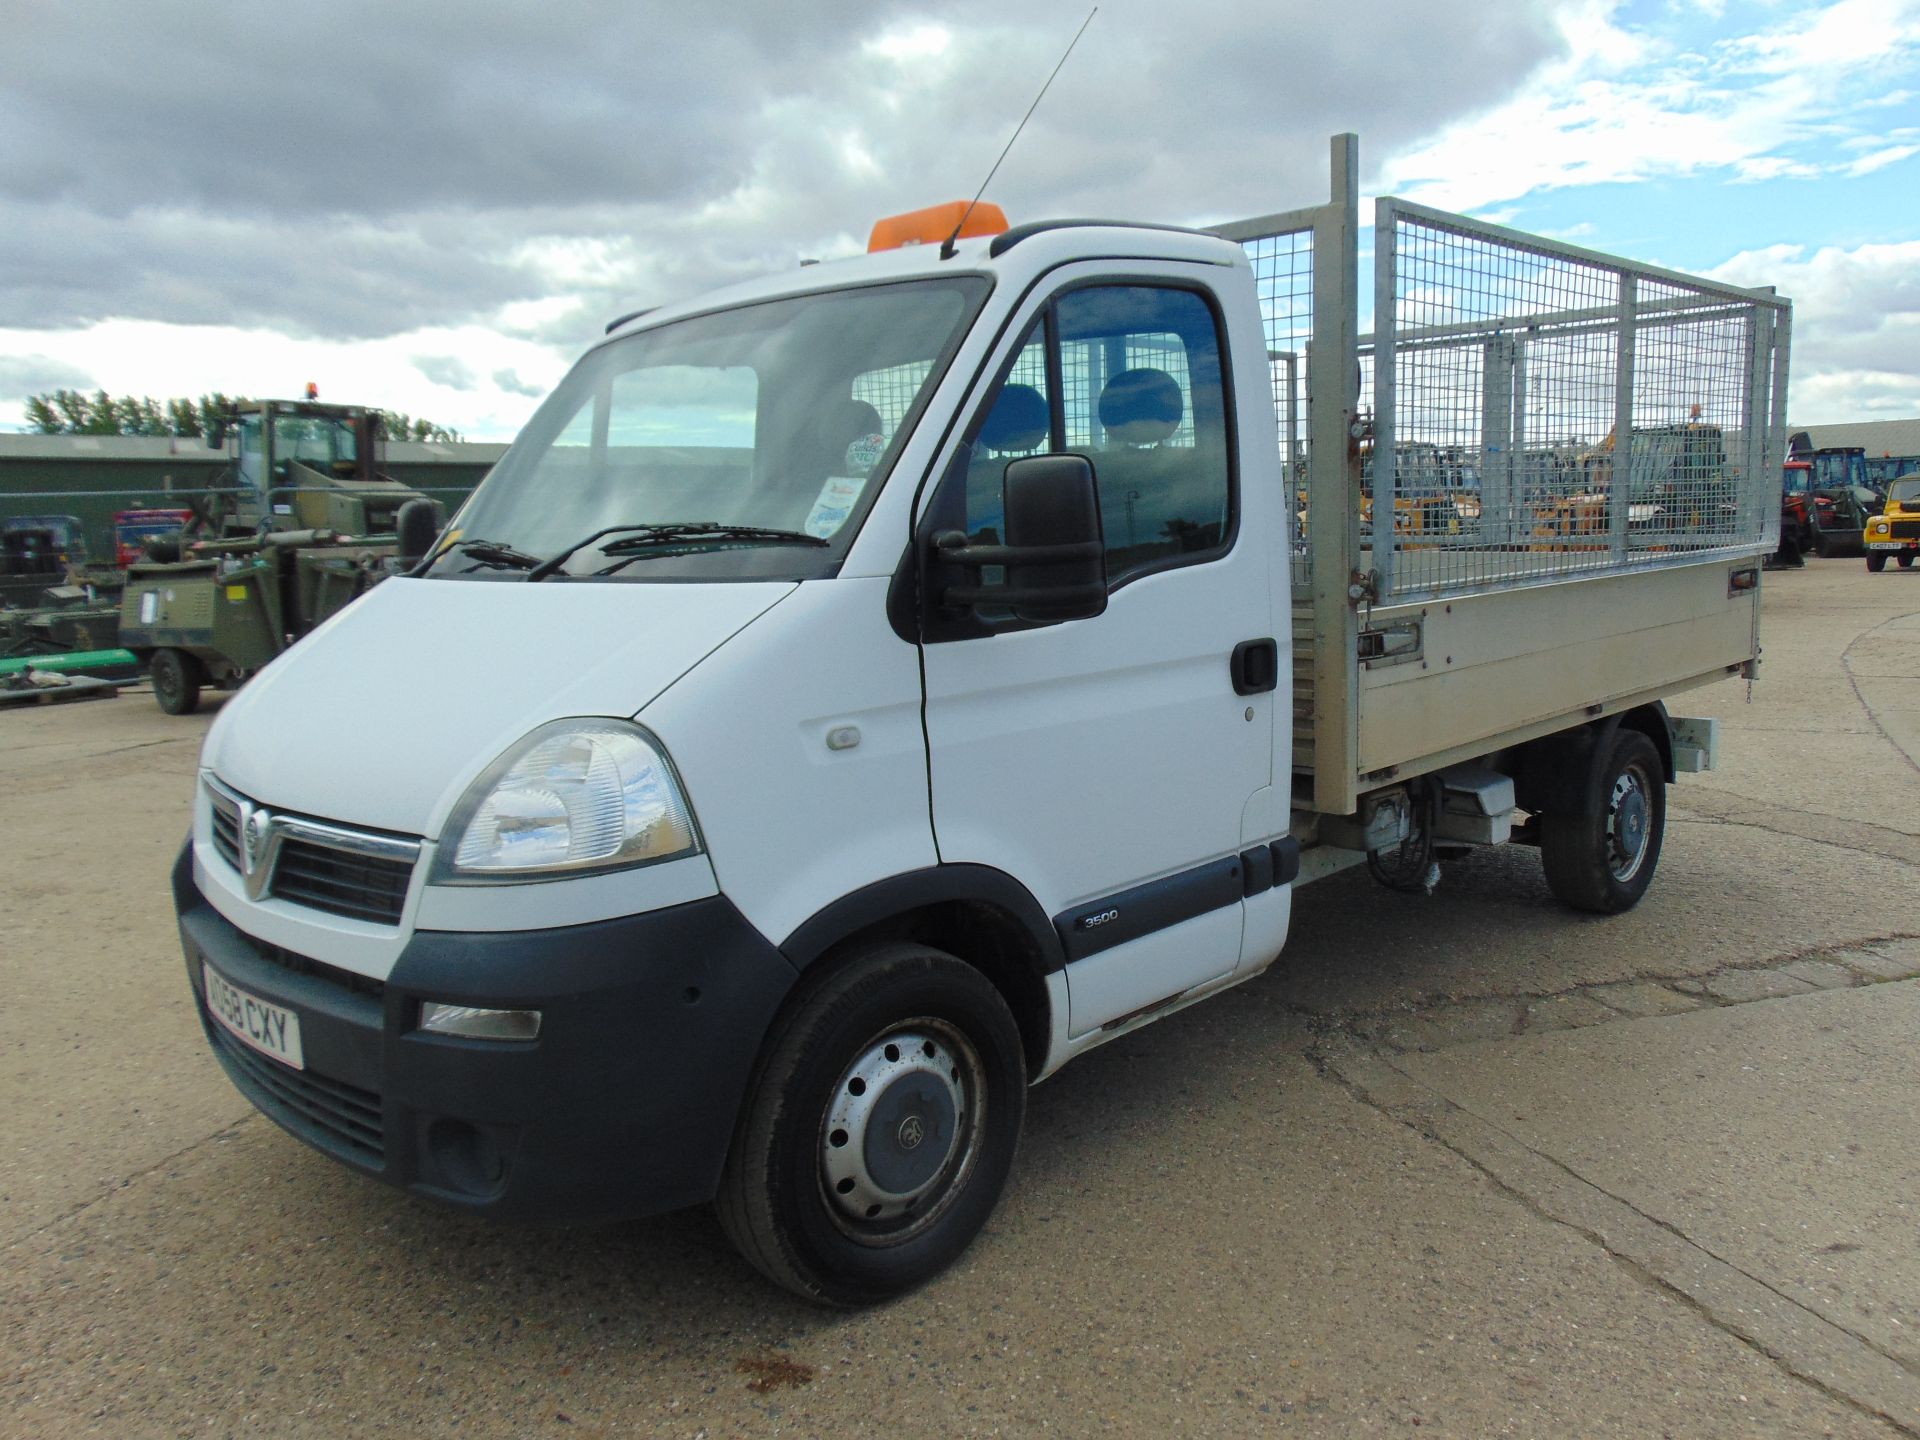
173, 136, 1788, 1304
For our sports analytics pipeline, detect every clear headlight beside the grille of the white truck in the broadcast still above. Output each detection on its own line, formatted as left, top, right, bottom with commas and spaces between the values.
432, 720, 701, 883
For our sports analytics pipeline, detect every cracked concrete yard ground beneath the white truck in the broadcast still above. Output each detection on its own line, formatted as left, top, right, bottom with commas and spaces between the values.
0, 561, 1920, 1436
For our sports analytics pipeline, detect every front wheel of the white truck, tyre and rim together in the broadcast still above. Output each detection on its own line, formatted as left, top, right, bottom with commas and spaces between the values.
718, 945, 1027, 1306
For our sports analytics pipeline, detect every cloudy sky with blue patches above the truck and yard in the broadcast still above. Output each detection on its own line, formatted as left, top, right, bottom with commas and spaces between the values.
0, 0, 1920, 440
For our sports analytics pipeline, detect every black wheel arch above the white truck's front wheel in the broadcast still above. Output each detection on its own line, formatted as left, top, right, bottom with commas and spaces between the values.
780, 864, 1066, 1073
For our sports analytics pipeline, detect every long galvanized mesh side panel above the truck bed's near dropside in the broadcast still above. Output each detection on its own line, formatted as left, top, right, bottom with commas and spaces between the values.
1363, 200, 1784, 599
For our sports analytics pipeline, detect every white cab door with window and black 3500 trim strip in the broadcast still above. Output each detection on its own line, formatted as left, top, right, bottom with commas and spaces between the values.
920, 265, 1273, 1035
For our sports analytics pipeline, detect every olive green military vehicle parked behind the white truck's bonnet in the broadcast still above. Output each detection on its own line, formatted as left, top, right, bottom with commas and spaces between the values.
119, 399, 440, 714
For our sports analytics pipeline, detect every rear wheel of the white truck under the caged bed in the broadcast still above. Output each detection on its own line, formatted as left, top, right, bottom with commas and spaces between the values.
1540, 730, 1667, 916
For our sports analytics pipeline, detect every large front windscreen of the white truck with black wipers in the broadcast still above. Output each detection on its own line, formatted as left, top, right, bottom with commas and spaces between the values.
430, 276, 987, 582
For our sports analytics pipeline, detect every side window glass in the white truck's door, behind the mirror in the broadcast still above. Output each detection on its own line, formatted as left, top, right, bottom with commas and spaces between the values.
943, 286, 1233, 586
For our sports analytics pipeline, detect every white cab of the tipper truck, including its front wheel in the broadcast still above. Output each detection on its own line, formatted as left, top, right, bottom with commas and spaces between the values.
175, 216, 1298, 1298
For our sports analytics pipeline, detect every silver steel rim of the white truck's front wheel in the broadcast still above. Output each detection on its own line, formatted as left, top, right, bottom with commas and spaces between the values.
816, 1016, 987, 1246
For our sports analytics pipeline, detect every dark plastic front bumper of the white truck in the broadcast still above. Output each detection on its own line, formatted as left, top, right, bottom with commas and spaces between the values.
173, 847, 795, 1223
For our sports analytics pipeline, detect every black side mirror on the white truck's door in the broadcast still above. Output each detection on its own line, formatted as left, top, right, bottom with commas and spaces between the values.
933, 455, 1106, 624
